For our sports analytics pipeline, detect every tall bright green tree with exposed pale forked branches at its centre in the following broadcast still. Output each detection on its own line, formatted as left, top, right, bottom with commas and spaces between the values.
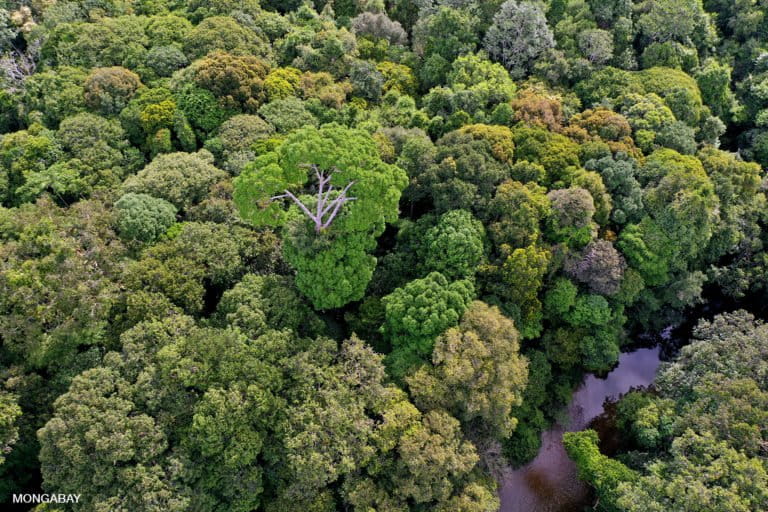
234, 124, 408, 309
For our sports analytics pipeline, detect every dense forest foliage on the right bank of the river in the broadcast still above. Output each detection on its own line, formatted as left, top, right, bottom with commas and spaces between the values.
565, 310, 768, 512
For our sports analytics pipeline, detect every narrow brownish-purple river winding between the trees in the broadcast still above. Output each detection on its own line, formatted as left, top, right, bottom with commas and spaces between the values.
499, 347, 660, 512
